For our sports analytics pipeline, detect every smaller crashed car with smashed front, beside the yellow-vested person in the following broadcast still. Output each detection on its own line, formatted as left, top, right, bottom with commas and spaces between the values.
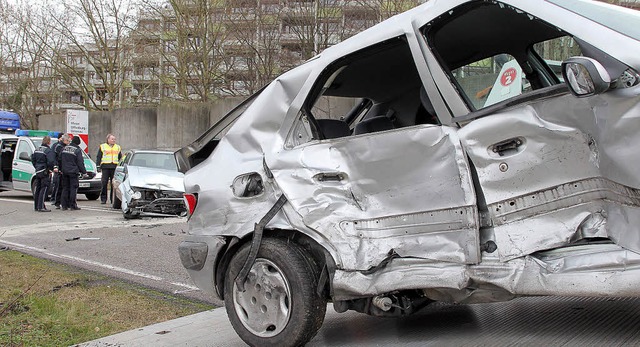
113, 149, 187, 219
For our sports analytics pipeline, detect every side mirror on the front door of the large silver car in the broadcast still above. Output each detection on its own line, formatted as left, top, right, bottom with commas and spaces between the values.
562, 57, 611, 98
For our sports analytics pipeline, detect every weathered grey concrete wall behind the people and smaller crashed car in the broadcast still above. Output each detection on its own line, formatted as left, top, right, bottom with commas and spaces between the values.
38, 98, 245, 154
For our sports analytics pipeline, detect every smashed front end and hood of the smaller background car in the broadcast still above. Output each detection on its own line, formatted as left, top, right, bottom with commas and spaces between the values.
118, 166, 186, 216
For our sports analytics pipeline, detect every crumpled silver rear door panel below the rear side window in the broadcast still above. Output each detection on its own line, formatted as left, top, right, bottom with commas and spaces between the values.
269, 125, 479, 270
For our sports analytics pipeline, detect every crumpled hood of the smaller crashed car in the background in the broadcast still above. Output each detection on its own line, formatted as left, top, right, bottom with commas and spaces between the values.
127, 165, 184, 192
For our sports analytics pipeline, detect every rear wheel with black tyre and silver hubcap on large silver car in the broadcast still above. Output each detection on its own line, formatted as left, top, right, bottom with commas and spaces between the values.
224, 239, 327, 346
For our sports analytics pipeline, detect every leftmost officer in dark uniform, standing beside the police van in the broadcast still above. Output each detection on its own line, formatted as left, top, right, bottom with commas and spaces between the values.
31, 136, 56, 212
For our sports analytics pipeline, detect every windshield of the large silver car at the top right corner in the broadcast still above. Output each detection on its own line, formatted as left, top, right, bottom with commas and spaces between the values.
549, 0, 640, 40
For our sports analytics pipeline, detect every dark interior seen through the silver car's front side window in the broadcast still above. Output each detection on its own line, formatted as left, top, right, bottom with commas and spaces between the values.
422, 1, 581, 110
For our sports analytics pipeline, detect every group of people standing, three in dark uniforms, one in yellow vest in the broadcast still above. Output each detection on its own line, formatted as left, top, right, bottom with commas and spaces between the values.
31, 133, 122, 212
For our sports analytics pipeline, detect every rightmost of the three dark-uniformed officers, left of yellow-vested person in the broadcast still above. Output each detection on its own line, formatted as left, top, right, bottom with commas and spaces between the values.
60, 136, 87, 211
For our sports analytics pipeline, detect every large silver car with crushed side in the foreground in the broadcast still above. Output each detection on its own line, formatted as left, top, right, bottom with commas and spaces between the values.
176, 0, 640, 346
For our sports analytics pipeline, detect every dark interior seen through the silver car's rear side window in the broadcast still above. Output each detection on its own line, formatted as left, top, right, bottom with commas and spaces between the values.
303, 36, 438, 139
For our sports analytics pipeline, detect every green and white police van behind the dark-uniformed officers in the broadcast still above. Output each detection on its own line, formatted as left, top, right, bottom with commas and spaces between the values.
0, 130, 102, 200
